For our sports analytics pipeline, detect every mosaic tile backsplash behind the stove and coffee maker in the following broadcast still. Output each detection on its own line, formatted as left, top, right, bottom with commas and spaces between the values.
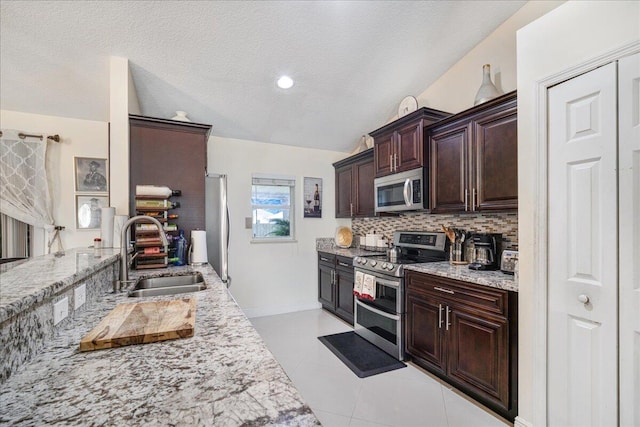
351, 212, 518, 249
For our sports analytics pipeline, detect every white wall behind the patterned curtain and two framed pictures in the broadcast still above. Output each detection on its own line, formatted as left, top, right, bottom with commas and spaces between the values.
0, 110, 109, 254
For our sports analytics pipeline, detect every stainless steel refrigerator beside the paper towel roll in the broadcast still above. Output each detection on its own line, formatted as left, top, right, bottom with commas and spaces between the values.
205, 174, 231, 287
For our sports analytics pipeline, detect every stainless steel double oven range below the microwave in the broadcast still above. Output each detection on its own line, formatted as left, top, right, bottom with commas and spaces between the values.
353, 231, 447, 360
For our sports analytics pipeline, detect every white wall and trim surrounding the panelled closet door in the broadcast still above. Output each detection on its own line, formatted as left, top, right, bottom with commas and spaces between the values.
517, 1, 640, 426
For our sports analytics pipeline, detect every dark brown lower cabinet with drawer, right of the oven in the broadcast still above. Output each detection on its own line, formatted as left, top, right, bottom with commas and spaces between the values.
406, 271, 518, 421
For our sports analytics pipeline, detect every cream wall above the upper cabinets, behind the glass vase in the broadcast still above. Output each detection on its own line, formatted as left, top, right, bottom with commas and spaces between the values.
416, 1, 563, 114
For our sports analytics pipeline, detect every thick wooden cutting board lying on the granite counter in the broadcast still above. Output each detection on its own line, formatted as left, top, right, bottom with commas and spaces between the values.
80, 298, 196, 351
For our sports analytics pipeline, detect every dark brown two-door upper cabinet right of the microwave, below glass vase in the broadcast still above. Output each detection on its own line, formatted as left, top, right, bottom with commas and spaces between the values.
425, 91, 518, 213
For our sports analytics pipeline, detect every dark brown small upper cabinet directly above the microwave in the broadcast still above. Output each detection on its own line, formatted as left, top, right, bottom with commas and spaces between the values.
369, 107, 450, 177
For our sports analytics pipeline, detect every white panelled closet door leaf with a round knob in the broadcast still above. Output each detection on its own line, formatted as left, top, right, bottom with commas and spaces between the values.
547, 63, 618, 427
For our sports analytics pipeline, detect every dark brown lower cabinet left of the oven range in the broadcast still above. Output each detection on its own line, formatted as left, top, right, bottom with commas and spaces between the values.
318, 252, 354, 325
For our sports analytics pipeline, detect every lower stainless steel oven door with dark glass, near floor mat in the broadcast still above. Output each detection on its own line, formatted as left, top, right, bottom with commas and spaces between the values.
354, 298, 404, 360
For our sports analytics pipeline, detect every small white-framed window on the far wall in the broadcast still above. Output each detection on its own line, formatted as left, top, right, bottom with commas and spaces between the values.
251, 175, 296, 241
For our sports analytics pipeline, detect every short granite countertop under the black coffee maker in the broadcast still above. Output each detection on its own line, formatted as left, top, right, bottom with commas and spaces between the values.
404, 261, 518, 292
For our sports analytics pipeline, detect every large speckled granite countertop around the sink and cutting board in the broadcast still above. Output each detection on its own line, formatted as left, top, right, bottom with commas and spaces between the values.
0, 261, 319, 426
